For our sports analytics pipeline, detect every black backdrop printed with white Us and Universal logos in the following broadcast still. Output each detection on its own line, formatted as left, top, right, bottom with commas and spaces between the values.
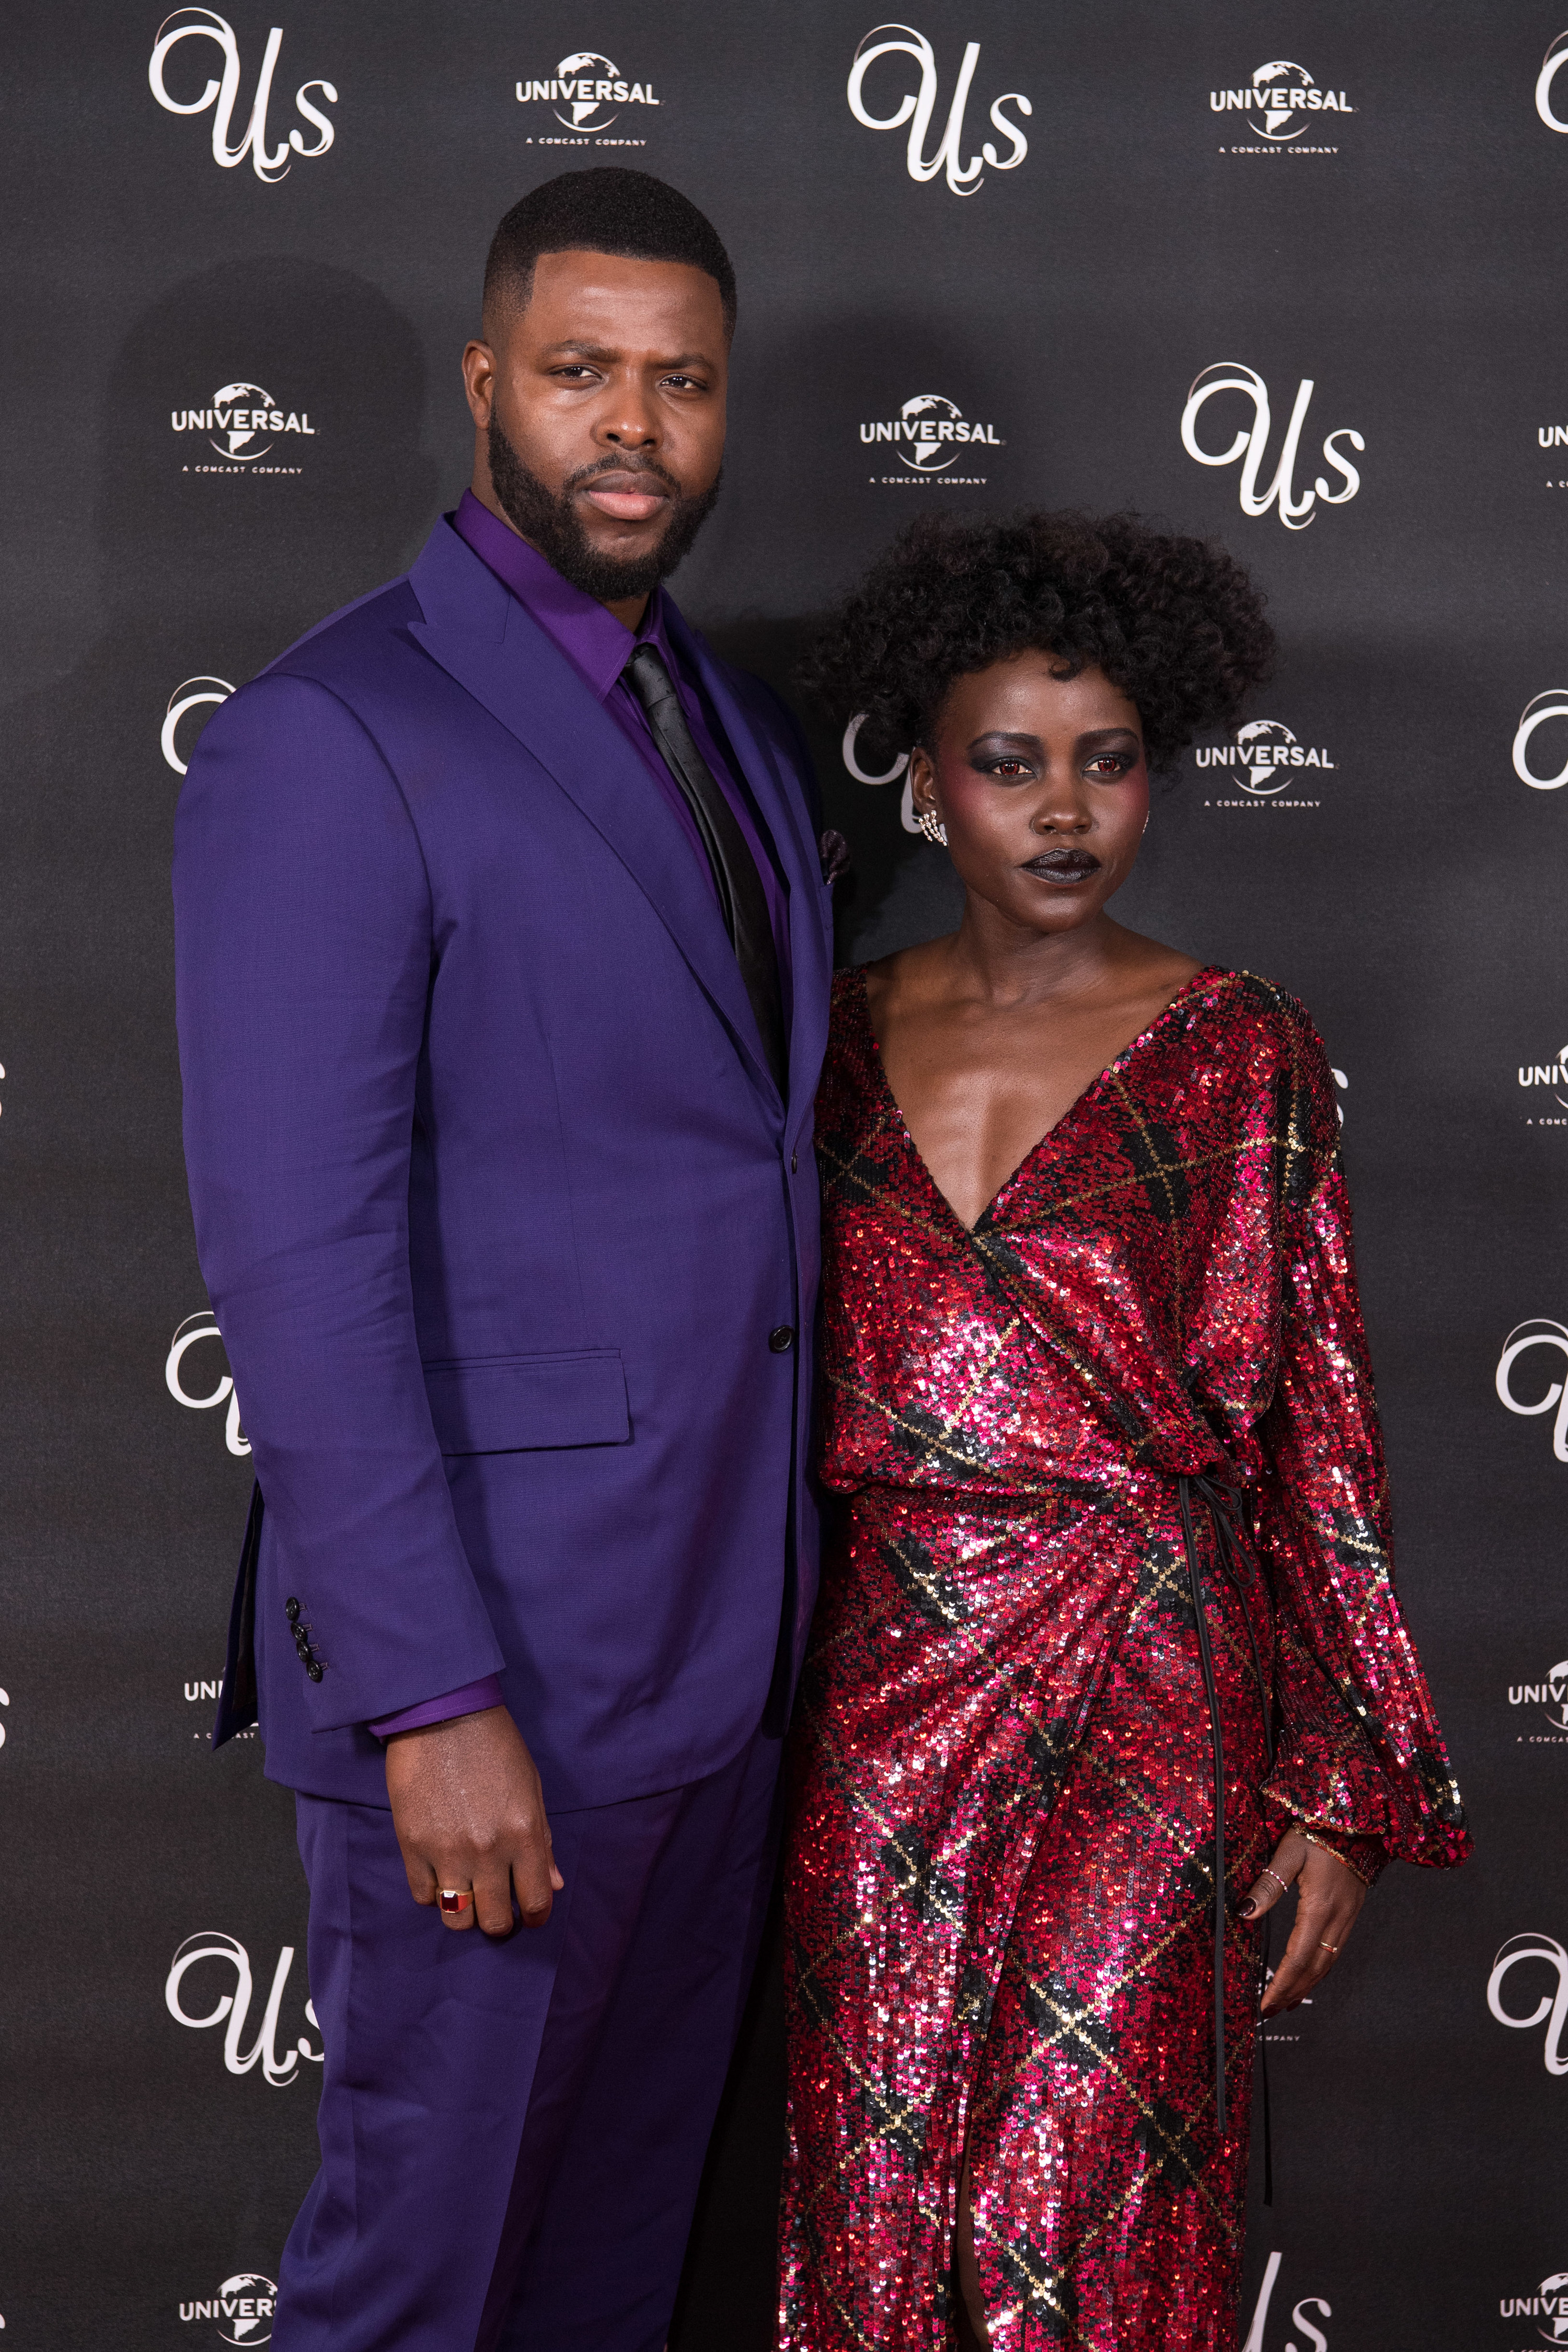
0, 0, 1568, 2352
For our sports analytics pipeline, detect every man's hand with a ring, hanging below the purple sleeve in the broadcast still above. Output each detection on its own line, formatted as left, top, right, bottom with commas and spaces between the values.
386, 1708, 567, 1936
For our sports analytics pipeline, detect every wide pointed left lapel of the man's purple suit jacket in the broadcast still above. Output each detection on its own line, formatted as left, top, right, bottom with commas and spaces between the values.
409, 520, 778, 1101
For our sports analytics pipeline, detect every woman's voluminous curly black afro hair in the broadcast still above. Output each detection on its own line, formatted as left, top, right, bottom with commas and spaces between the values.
802, 513, 1274, 767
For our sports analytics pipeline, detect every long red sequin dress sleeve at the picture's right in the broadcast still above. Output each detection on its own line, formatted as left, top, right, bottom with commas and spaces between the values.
1258, 1035, 1469, 1877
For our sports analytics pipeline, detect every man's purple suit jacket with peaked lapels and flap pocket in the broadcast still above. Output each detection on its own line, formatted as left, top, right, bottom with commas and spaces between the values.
174, 522, 832, 1809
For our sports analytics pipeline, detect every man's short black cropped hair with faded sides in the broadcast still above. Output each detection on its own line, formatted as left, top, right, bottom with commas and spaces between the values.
485, 165, 736, 334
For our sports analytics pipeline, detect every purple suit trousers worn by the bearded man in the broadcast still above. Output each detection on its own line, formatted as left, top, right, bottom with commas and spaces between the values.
273, 1734, 780, 2352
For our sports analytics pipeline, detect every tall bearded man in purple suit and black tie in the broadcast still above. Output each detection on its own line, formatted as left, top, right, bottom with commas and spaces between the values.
174, 169, 832, 2352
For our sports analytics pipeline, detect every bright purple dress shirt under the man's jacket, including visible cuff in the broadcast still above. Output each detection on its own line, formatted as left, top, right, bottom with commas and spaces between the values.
369, 489, 790, 1740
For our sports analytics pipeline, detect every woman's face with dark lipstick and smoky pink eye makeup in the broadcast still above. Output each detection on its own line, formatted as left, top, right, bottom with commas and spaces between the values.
910, 652, 1149, 931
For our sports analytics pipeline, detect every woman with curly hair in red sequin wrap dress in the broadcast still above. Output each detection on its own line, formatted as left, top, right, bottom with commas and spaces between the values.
780, 515, 1467, 2352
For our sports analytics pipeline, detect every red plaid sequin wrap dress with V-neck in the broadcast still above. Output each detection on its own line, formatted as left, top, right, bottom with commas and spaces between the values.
778, 969, 1469, 2352
